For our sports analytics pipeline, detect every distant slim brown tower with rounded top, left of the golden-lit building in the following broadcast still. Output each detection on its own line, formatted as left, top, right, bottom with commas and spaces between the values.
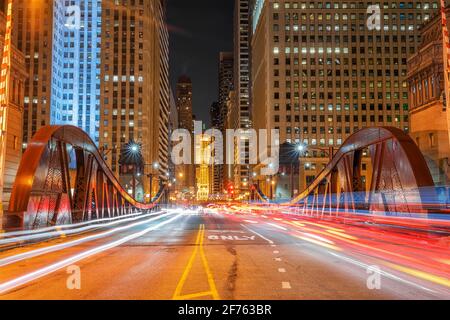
176, 75, 196, 194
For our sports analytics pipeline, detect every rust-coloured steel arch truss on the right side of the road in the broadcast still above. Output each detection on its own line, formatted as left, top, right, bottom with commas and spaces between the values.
256, 127, 436, 214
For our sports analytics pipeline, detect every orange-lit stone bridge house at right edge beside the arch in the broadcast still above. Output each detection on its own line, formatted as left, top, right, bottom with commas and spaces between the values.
408, 6, 450, 186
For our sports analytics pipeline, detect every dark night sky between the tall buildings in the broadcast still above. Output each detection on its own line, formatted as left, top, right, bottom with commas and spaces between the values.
167, 0, 234, 126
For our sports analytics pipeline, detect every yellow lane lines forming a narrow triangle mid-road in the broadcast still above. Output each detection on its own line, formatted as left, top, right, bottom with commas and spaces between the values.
172, 224, 220, 300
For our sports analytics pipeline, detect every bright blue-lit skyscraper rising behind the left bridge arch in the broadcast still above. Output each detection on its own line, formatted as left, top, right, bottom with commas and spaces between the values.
50, 0, 102, 144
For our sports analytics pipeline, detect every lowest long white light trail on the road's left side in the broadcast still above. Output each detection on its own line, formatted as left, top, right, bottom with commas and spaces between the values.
0, 214, 181, 294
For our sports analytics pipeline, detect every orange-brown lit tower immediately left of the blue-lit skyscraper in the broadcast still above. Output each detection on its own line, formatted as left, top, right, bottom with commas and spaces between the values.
12, 0, 54, 147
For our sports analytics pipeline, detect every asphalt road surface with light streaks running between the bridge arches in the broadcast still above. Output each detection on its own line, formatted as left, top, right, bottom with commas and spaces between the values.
0, 210, 450, 300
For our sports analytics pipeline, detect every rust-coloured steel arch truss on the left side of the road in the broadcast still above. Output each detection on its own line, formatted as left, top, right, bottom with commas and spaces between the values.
5, 126, 163, 229
